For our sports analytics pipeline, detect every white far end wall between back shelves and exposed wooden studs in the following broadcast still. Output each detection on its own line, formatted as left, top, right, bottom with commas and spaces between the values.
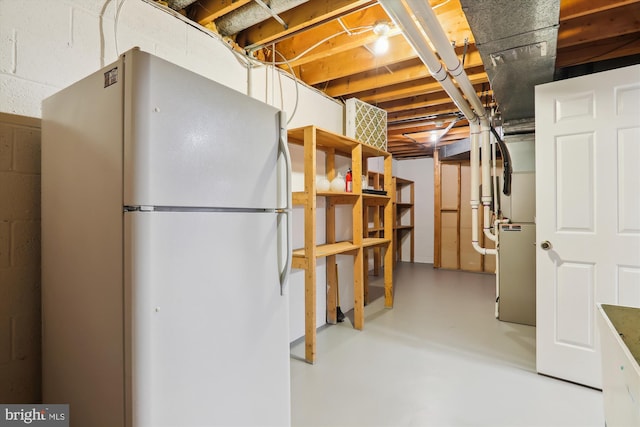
394, 158, 434, 264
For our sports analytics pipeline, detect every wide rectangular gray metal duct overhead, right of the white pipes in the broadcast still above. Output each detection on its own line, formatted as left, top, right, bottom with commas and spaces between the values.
460, 0, 560, 126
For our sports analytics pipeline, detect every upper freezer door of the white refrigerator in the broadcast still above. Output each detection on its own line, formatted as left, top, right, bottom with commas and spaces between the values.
124, 50, 282, 209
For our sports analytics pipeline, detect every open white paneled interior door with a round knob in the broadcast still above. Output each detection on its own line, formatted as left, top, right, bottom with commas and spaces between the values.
536, 66, 640, 388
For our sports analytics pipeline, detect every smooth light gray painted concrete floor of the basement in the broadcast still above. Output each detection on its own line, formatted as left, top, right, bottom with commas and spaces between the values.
291, 263, 604, 427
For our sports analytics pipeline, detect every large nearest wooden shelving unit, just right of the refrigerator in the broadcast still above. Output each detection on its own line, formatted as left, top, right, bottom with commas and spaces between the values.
288, 126, 393, 363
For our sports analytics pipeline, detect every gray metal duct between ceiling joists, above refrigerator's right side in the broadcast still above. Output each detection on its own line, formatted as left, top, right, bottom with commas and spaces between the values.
215, 0, 308, 36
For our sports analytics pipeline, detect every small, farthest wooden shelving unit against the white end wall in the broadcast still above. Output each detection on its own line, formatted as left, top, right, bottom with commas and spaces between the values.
393, 177, 415, 262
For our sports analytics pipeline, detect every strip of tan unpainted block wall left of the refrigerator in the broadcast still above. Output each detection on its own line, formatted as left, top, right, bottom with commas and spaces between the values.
0, 113, 41, 403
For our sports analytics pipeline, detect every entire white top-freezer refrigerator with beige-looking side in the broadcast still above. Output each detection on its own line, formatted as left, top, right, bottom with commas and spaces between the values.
42, 49, 291, 427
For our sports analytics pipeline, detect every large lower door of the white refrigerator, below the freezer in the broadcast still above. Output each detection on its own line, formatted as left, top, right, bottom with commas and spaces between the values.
125, 212, 290, 427
